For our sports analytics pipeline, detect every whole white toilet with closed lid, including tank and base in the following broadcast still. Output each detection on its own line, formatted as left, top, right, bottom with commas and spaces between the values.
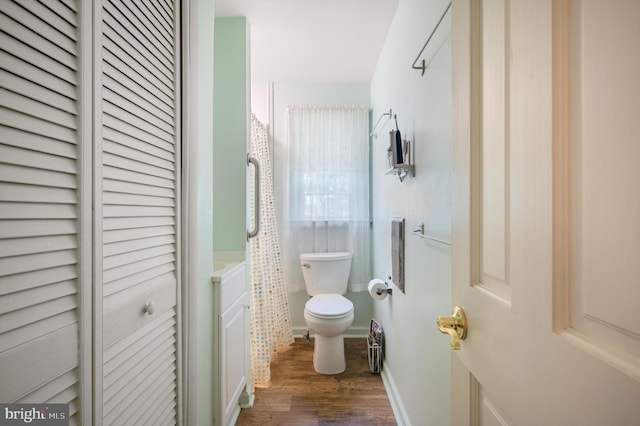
300, 252, 354, 374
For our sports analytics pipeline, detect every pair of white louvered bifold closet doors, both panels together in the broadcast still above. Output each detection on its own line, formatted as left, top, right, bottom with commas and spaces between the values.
0, 0, 181, 425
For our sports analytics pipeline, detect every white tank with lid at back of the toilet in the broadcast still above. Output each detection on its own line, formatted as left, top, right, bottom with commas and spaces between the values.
300, 252, 352, 296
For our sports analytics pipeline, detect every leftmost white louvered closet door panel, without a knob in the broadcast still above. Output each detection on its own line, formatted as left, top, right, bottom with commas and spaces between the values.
0, 0, 91, 424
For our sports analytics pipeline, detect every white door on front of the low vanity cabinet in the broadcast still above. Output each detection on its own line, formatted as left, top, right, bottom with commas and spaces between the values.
220, 292, 248, 424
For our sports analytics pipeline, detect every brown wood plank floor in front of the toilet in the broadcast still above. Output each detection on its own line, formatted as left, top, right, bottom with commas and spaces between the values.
236, 338, 396, 426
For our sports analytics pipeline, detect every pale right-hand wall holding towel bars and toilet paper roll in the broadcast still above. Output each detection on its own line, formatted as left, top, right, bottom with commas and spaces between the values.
371, 0, 452, 425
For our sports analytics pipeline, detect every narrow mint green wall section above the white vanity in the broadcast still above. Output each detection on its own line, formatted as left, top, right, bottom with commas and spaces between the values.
213, 18, 250, 251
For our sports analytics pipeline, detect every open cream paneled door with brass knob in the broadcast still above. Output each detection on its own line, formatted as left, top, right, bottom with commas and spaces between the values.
450, 0, 640, 426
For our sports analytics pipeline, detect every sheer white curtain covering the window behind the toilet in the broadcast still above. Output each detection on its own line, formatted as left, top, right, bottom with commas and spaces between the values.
283, 106, 371, 291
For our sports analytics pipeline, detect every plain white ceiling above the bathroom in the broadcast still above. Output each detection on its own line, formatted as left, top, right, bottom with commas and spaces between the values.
215, 0, 399, 83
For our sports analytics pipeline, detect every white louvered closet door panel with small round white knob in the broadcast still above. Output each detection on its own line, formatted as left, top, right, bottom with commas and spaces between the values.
96, 0, 180, 425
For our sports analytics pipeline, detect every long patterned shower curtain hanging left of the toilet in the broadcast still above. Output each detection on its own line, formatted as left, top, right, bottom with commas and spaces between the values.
249, 114, 293, 387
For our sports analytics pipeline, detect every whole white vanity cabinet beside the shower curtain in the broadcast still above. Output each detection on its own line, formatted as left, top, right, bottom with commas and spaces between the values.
212, 261, 251, 426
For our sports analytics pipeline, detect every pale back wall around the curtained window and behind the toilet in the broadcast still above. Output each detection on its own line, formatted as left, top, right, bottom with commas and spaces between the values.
273, 83, 372, 336
